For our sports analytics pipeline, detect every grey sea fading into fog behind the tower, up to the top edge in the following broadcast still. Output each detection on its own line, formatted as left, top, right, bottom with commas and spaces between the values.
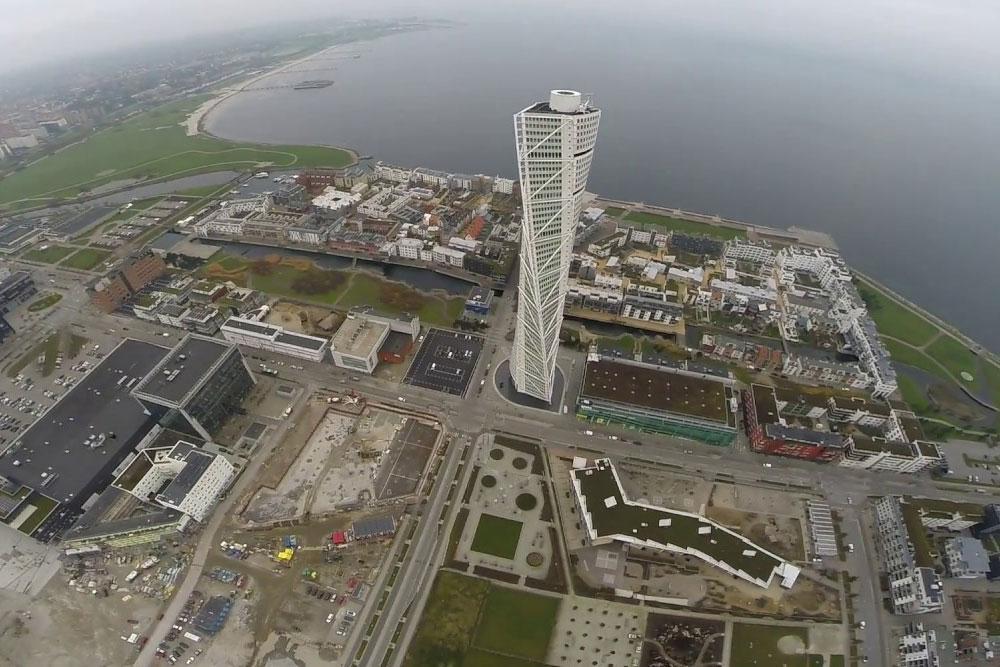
207, 7, 1000, 350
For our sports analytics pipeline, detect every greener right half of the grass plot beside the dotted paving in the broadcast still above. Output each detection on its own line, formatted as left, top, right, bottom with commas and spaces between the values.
475, 588, 560, 661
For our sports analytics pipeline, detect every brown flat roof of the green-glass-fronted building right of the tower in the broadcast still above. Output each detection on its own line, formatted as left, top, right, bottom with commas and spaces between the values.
580, 358, 732, 424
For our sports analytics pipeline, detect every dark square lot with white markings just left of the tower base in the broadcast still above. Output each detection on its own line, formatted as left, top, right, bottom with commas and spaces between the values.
404, 329, 483, 396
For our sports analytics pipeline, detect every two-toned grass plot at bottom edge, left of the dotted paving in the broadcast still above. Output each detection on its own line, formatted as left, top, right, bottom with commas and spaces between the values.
403, 572, 560, 667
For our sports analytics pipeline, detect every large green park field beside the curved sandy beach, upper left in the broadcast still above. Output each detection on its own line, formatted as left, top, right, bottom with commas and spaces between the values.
0, 96, 353, 208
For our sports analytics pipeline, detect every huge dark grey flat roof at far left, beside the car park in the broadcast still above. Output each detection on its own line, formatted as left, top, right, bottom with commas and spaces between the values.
0, 339, 167, 503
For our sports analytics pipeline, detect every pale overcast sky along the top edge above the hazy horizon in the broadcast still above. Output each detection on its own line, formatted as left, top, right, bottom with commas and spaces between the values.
0, 0, 1000, 85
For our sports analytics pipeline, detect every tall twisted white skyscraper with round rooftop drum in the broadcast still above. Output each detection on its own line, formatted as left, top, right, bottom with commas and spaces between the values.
510, 90, 601, 401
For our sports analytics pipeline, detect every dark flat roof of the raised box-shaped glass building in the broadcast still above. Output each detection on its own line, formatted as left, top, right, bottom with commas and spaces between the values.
134, 334, 235, 405
